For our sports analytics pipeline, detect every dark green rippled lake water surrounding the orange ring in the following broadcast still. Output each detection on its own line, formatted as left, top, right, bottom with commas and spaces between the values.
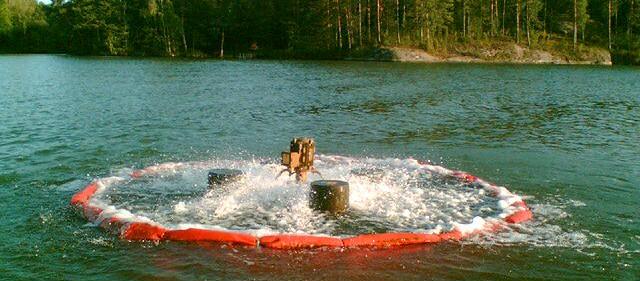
0, 55, 640, 280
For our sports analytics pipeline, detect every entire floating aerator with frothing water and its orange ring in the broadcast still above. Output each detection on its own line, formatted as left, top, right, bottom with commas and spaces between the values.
71, 141, 533, 249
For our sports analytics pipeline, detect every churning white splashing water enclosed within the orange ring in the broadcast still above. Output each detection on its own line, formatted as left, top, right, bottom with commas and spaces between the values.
96, 156, 501, 236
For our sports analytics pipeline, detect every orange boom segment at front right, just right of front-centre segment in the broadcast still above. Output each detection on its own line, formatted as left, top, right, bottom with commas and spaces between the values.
342, 233, 442, 247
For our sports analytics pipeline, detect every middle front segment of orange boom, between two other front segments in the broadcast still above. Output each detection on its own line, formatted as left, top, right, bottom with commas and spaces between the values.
260, 234, 343, 249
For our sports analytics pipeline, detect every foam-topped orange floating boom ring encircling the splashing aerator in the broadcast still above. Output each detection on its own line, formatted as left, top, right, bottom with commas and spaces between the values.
70, 156, 533, 249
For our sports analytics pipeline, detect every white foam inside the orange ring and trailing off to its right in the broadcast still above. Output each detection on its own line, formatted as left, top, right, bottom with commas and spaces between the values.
85, 156, 640, 256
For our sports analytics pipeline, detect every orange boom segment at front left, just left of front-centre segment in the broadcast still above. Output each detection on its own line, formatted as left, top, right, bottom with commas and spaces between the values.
163, 228, 258, 246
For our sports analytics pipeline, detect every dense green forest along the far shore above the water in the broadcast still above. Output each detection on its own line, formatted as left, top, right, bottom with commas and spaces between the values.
0, 0, 640, 63
